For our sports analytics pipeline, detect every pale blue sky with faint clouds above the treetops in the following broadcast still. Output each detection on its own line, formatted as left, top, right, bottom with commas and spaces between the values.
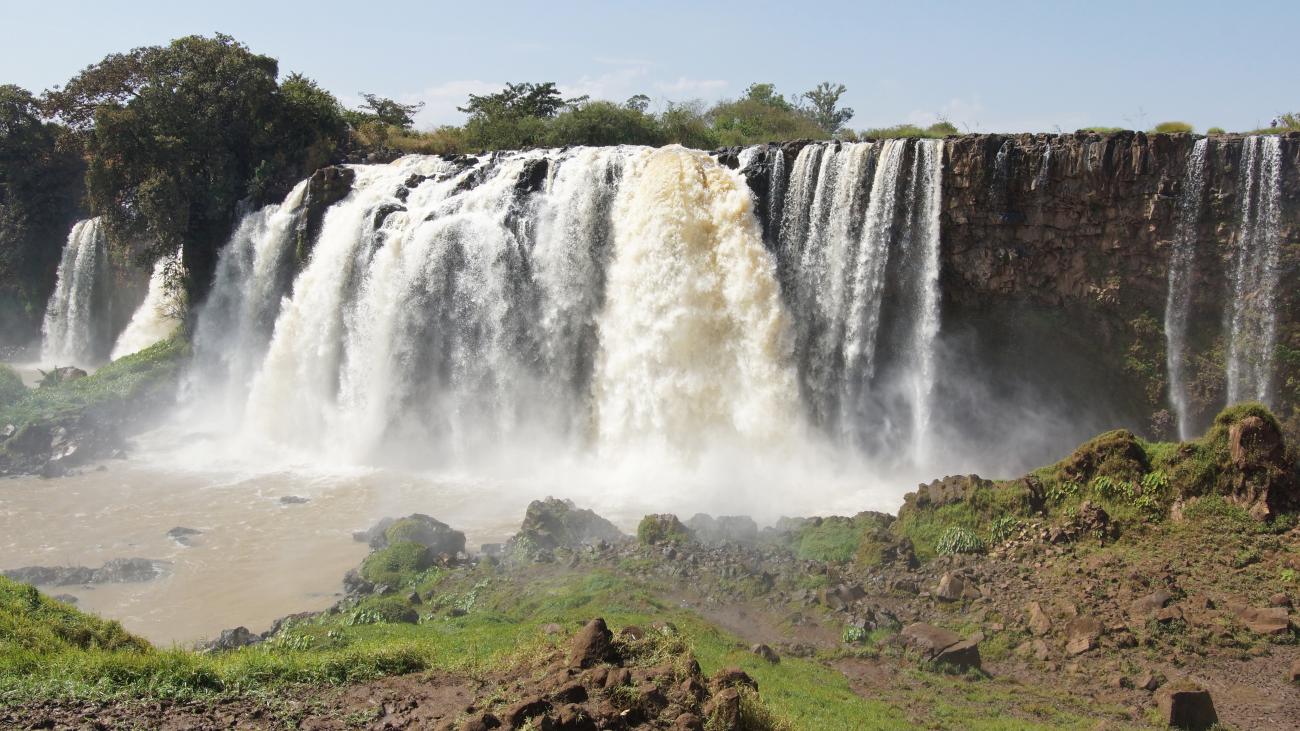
0, 0, 1300, 131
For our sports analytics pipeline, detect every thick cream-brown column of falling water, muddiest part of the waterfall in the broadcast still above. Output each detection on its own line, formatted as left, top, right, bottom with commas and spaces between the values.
594, 147, 798, 449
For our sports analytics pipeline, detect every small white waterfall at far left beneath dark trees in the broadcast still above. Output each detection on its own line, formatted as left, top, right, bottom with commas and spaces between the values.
40, 219, 109, 366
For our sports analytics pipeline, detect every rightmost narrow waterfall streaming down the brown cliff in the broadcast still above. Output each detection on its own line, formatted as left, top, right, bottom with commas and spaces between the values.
1227, 135, 1282, 405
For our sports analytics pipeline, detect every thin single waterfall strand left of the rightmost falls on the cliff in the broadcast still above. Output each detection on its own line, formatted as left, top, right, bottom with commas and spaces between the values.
1165, 138, 1209, 441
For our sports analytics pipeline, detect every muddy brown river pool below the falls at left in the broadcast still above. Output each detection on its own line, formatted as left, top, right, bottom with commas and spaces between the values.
0, 452, 527, 645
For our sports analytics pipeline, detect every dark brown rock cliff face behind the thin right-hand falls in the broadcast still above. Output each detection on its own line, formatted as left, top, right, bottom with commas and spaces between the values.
720, 131, 1300, 447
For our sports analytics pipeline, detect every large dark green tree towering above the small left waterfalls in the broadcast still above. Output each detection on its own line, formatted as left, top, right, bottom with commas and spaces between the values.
46, 34, 347, 292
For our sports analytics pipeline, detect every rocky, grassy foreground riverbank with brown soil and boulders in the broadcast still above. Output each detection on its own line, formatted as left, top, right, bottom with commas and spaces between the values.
0, 407, 1300, 730
